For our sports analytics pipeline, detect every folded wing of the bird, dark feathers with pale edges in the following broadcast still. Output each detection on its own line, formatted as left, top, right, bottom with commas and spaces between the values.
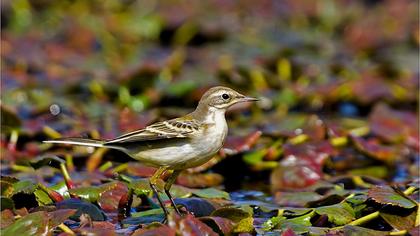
104, 118, 200, 145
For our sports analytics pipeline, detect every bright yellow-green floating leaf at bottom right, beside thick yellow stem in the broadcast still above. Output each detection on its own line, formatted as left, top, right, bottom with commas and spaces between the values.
315, 202, 355, 225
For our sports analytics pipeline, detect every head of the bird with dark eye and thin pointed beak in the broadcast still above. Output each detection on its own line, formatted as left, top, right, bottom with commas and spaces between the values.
199, 86, 258, 110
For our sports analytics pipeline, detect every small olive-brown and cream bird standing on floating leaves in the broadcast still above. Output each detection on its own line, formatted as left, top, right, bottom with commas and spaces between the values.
44, 86, 258, 219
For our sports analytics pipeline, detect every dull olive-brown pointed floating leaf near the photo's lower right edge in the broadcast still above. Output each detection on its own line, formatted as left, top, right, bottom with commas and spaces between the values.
368, 186, 417, 208
